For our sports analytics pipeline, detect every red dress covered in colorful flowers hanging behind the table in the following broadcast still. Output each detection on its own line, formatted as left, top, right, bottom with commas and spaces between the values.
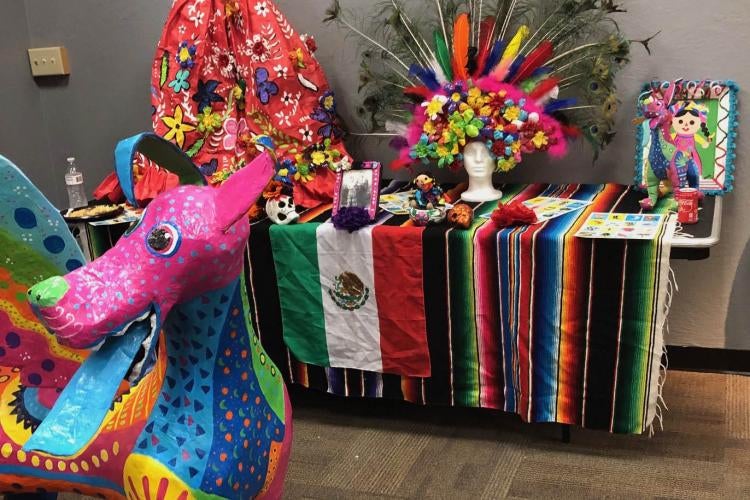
152, 0, 351, 206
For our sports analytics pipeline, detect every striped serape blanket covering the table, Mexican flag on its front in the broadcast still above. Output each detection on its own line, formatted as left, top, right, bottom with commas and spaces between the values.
246, 184, 674, 433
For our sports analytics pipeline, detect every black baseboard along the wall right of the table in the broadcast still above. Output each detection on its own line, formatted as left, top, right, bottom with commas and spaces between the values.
667, 346, 750, 373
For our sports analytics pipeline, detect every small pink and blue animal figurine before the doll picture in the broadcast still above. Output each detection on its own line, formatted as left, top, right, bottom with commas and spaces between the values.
640, 82, 699, 210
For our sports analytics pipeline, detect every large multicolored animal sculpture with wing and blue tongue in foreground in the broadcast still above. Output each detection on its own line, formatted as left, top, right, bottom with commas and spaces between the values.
0, 139, 292, 500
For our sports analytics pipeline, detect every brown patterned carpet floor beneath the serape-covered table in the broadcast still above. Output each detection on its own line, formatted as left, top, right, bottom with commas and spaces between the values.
51, 371, 750, 500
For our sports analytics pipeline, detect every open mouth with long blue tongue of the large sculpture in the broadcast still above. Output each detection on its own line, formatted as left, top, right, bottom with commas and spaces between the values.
24, 305, 161, 456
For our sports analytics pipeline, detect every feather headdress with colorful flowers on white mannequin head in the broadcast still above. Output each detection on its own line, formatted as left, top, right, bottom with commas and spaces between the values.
325, 0, 650, 170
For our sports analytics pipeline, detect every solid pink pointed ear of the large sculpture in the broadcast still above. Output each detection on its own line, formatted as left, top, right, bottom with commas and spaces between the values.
216, 151, 274, 231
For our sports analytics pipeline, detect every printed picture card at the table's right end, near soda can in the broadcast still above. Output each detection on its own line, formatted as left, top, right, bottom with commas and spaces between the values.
576, 212, 666, 240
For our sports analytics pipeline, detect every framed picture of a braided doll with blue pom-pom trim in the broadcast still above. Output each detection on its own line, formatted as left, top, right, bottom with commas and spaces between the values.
635, 80, 738, 195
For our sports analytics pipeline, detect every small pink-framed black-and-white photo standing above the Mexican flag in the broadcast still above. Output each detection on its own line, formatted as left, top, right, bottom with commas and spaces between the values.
333, 161, 380, 219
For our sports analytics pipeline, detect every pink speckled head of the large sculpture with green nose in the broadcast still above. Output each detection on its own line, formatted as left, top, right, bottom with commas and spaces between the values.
29, 153, 273, 356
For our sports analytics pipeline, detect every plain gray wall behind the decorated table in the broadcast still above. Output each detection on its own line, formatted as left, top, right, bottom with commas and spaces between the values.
0, 0, 750, 350
